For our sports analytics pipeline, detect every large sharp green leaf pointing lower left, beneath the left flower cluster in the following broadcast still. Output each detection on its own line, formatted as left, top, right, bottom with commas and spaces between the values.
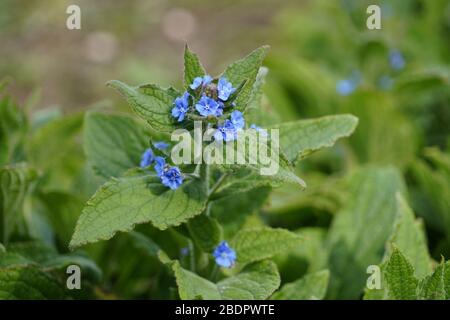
70, 176, 207, 248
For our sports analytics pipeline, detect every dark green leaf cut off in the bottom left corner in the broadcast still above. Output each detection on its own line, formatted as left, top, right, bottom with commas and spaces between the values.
0, 266, 66, 300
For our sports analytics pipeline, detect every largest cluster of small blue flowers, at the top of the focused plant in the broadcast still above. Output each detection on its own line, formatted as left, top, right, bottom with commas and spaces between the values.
172, 75, 250, 142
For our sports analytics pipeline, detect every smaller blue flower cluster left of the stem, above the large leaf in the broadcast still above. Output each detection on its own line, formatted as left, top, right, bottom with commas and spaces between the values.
140, 142, 183, 190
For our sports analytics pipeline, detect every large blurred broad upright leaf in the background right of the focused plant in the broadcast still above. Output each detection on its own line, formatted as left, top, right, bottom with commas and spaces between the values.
327, 166, 405, 299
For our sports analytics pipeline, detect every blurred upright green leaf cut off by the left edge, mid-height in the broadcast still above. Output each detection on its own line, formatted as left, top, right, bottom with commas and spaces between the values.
0, 165, 36, 244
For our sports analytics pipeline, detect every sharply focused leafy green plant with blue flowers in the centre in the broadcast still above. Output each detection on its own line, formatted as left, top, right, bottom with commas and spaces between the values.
70, 43, 357, 299
